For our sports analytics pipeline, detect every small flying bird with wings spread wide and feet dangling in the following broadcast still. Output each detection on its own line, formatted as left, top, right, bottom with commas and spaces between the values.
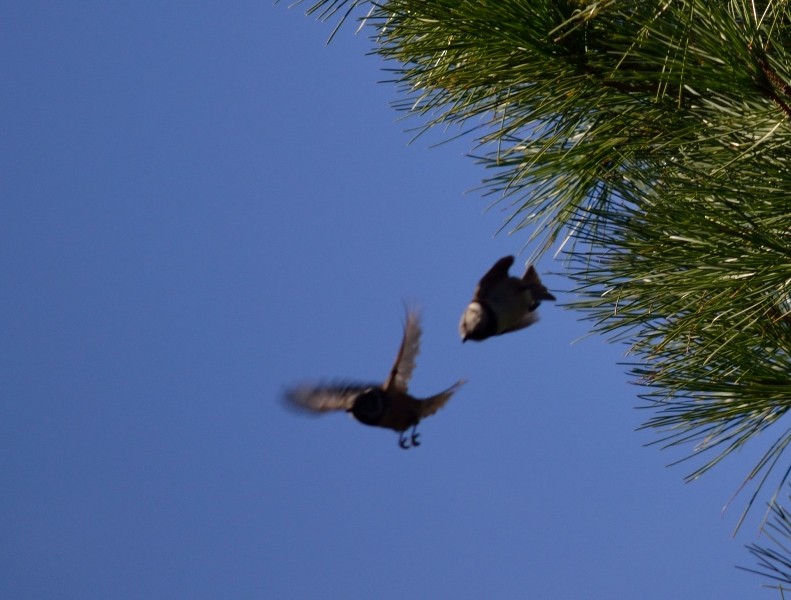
285, 310, 465, 449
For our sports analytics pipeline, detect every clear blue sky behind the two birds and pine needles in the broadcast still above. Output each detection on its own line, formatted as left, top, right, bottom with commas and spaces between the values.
0, 0, 777, 600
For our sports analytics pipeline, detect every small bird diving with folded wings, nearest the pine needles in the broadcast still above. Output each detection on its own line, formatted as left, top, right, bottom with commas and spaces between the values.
459, 256, 555, 343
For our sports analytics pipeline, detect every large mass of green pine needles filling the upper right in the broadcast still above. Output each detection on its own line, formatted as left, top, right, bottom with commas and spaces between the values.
296, 0, 791, 524
